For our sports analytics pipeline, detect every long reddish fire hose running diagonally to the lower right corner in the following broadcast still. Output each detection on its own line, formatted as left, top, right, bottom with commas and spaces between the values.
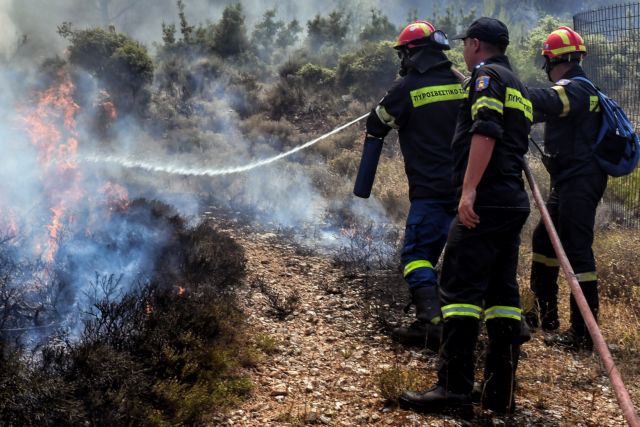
524, 161, 640, 427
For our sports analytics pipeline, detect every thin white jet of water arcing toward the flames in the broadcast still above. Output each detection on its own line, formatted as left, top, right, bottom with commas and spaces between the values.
84, 113, 369, 176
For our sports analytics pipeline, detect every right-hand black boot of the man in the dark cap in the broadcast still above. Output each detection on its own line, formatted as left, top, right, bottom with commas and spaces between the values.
481, 319, 521, 414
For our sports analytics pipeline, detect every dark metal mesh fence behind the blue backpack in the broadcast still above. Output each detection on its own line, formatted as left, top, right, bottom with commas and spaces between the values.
573, 3, 640, 229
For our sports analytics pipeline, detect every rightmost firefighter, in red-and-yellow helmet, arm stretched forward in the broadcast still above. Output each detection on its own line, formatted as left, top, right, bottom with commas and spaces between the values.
528, 27, 607, 350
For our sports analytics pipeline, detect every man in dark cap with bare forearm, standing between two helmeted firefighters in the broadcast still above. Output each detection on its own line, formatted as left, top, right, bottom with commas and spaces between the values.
400, 18, 533, 413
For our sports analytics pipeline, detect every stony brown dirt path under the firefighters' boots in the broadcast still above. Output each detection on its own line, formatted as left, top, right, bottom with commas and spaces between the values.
206, 211, 640, 426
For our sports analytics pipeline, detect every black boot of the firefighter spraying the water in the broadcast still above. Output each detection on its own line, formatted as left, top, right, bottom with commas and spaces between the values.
391, 286, 442, 352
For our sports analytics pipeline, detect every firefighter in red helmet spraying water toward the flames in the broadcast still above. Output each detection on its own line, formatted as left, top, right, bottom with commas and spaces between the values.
354, 21, 465, 350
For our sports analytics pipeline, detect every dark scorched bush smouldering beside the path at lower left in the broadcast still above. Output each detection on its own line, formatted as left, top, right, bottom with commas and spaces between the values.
0, 200, 255, 425
